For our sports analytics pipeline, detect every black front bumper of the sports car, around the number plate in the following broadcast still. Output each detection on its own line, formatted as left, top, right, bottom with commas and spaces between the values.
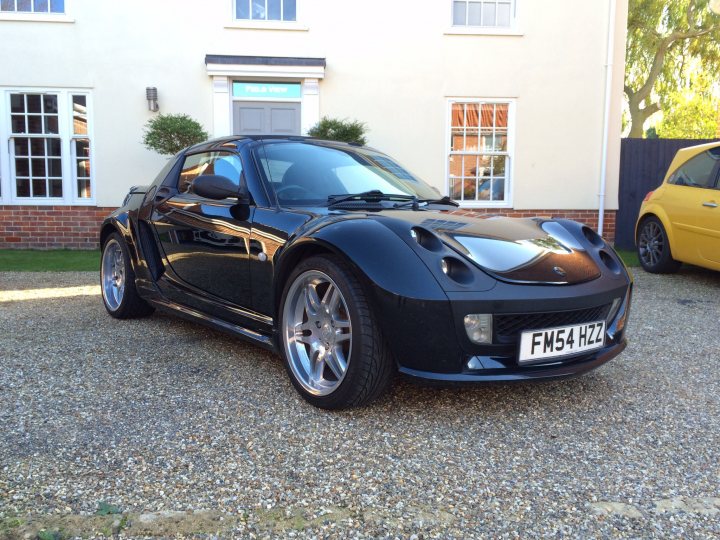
368, 276, 632, 383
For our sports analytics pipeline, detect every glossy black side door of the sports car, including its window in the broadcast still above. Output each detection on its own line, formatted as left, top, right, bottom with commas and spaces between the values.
152, 150, 252, 306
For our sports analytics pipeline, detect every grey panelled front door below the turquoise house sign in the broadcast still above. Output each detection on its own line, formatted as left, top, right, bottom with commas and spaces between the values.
233, 101, 300, 135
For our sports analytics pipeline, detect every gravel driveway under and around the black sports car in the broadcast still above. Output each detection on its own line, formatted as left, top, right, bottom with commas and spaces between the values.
0, 267, 720, 538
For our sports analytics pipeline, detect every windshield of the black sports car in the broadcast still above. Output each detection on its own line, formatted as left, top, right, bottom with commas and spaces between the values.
256, 142, 440, 206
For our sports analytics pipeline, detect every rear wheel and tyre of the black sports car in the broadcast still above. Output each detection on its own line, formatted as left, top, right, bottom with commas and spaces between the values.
100, 232, 155, 319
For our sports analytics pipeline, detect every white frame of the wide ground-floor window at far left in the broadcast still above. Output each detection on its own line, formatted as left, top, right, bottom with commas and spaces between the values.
0, 86, 97, 206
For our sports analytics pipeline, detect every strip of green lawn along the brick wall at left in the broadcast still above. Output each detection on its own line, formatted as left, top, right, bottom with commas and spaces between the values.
0, 249, 100, 272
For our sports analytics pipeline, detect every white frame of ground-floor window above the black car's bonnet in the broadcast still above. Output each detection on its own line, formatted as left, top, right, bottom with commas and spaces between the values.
443, 97, 517, 208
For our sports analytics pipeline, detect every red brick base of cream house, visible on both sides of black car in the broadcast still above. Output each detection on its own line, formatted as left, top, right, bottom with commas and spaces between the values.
0, 206, 615, 249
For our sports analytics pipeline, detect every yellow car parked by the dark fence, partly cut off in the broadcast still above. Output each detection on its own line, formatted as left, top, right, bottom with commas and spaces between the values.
635, 143, 720, 273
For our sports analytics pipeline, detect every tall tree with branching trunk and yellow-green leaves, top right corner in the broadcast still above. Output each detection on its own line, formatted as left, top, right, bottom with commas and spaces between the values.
625, 0, 720, 137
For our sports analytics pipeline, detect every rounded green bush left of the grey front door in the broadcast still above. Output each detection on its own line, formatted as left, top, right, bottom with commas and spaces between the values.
143, 114, 208, 156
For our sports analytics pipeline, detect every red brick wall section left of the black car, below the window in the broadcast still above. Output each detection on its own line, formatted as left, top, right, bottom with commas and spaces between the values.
0, 206, 115, 249
